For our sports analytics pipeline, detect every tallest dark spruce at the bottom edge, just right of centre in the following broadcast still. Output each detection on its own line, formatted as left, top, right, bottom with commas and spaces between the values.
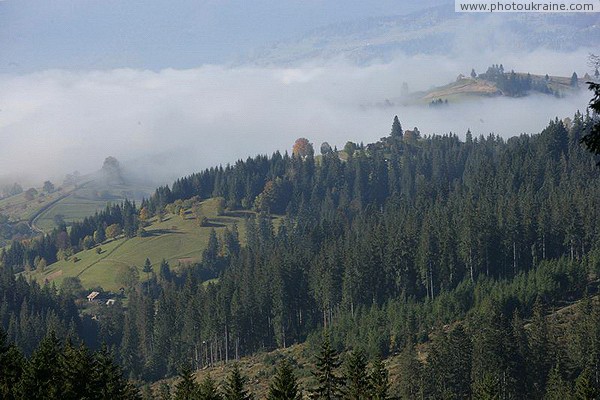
310, 334, 343, 400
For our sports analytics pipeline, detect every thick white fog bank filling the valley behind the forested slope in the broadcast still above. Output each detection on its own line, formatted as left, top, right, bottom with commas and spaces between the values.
0, 50, 591, 184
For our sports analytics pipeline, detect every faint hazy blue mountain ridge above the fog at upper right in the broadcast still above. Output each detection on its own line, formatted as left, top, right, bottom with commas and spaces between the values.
248, 3, 600, 65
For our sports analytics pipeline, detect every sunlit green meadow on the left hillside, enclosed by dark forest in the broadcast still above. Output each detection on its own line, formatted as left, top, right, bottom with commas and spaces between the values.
29, 199, 252, 291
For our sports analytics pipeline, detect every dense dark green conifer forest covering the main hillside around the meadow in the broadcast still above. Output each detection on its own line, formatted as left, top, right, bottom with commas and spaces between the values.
0, 96, 600, 399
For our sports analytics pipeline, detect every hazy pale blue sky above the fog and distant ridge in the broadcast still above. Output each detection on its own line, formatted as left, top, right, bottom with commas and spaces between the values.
0, 0, 440, 73
